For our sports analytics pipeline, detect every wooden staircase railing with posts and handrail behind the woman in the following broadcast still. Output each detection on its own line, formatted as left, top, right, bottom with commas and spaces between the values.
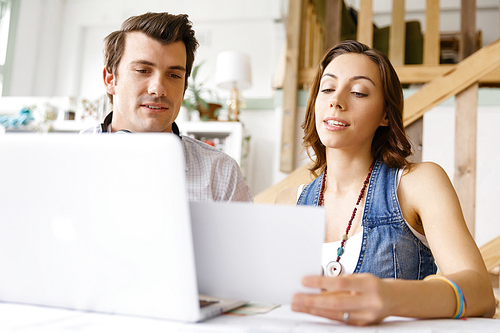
255, 0, 500, 240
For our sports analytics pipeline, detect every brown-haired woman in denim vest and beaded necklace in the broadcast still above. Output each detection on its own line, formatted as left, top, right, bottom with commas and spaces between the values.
276, 41, 495, 325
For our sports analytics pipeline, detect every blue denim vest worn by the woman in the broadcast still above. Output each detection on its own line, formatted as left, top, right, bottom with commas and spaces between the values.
297, 161, 437, 280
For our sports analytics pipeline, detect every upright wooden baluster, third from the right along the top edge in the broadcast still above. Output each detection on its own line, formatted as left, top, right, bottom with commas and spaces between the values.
389, 0, 406, 66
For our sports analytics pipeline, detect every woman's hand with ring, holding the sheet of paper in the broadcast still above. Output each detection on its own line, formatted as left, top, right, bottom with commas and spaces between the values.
292, 274, 391, 326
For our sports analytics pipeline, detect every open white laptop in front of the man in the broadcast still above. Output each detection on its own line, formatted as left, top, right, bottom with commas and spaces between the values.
0, 134, 324, 322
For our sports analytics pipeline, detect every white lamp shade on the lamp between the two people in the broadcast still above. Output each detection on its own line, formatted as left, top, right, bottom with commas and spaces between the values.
215, 51, 252, 90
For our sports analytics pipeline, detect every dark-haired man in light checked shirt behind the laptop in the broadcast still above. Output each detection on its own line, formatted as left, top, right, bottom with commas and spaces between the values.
82, 13, 252, 201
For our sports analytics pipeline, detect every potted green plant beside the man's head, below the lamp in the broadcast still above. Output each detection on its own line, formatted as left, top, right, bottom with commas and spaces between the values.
182, 62, 222, 121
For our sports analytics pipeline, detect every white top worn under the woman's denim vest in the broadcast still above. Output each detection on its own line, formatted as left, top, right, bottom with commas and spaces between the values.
297, 169, 429, 274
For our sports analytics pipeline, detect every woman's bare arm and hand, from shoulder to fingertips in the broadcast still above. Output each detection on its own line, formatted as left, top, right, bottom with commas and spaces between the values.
292, 163, 495, 325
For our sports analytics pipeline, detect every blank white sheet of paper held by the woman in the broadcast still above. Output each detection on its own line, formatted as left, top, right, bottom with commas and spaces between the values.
191, 198, 325, 304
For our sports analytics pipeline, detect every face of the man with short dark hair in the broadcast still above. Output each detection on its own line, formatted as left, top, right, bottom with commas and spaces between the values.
104, 31, 186, 132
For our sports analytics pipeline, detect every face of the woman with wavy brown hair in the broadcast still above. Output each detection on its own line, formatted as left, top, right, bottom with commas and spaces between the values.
315, 53, 388, 151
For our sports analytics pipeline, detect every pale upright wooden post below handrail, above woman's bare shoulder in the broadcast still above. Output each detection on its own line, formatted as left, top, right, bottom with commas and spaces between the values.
453, 83, 479, 237
